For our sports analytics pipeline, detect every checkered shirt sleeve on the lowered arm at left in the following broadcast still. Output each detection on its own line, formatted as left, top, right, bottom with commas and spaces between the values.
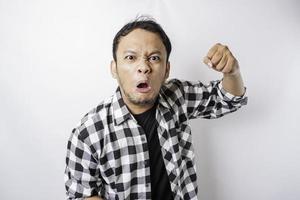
64, 129, 101, 200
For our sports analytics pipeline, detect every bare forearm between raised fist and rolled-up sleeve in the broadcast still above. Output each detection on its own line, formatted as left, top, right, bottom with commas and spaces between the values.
222, 71, 245, 96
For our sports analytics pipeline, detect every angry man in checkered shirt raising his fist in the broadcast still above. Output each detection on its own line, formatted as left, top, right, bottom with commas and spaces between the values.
65, 18, 247, 200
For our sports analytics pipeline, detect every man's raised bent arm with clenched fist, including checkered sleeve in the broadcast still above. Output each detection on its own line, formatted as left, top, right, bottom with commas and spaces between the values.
176, 44, 247, 119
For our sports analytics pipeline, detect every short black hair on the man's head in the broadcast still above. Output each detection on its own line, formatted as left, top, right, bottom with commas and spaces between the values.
112, 15, 172, 62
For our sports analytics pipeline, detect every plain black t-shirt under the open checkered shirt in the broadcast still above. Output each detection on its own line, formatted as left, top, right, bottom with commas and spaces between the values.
134, 105, 173, 200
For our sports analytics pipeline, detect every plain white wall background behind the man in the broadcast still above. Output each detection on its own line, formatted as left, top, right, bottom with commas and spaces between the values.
0, 0, 300, 200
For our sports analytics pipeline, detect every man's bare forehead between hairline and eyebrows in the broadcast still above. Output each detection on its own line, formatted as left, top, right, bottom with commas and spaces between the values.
118, 29, 165, 53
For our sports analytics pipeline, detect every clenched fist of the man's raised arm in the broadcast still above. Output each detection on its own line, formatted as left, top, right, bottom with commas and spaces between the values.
203, 43, 239, 75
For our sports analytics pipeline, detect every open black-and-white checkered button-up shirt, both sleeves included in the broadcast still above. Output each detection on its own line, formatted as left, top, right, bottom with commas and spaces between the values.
65, 79, 247, 200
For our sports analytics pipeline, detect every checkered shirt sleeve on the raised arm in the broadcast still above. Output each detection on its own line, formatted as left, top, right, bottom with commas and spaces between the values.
177, 80, 248, 119
